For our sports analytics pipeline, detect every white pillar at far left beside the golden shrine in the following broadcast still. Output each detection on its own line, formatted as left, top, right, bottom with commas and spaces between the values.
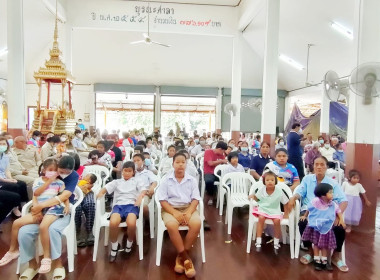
7, 0, 26, 135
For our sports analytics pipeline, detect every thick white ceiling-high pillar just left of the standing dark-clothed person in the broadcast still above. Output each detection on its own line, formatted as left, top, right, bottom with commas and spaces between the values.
261, 0, 280, 147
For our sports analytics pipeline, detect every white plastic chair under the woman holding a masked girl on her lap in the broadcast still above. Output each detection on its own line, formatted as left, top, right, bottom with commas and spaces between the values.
16, 187, 83, 274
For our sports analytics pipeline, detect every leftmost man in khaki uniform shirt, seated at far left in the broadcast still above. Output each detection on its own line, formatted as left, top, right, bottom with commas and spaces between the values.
13, 136, 41, 173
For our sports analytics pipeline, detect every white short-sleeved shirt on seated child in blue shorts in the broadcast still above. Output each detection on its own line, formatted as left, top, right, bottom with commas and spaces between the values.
105, 177, 142, 206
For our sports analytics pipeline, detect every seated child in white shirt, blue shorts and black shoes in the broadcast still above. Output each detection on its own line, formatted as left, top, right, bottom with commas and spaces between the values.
97, 161, 146, 262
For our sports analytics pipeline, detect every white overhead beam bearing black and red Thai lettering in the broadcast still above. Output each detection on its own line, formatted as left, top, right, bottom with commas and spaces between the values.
67, 0, 238, 36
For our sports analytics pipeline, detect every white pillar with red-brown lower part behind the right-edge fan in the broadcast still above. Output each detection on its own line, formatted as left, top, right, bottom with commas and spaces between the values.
346, 0, 380, 232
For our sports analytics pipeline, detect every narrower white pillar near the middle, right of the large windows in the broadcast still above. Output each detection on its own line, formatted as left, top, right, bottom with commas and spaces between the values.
230, 32, 243, 141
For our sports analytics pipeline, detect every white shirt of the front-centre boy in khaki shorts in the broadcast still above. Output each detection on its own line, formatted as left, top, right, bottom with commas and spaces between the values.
156, 171, 201, 207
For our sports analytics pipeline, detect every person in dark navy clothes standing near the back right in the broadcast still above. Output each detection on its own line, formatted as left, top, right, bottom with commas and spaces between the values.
287, 123, 305, 181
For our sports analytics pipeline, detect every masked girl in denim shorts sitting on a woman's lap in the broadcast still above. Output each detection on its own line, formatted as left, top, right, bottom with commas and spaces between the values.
0, 159, 70, 273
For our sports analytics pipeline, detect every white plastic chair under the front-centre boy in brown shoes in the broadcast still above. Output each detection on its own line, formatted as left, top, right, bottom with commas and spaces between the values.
155, 191, 206, 266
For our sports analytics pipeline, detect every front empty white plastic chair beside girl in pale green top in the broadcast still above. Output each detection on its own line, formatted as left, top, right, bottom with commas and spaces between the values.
222, 172, 256, 234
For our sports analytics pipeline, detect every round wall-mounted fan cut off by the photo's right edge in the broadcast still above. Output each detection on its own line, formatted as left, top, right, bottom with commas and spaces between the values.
350, 62, 380, 104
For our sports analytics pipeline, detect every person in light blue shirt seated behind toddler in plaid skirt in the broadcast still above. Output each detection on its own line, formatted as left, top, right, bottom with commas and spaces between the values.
288, 156, 348, 272
